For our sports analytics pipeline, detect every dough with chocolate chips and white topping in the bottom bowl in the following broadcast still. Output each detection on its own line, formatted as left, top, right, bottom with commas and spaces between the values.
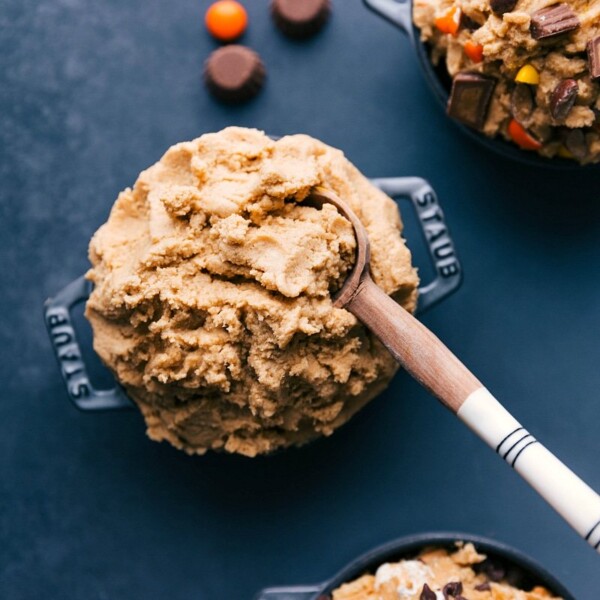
333, 544, 560, 600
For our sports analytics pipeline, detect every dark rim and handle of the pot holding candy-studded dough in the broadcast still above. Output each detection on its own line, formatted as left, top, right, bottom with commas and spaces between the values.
363, 0, 600, 171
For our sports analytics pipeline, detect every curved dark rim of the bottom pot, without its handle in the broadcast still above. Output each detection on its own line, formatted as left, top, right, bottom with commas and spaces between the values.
315, 532, 575, 600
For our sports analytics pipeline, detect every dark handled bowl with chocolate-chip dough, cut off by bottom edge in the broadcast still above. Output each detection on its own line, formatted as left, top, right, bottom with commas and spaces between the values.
256, 532, 574, 600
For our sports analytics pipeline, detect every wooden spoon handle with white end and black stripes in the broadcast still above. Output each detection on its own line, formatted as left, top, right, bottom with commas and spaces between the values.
346, 274, 600, 552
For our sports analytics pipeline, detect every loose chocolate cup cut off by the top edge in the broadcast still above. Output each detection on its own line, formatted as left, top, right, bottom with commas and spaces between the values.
271, 0, 331, 38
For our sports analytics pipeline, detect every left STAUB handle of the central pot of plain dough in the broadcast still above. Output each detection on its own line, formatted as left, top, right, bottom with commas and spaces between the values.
44, 276, 132, 411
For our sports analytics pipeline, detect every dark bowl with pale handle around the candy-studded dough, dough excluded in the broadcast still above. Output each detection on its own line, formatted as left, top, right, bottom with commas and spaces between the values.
363, 0, 600, 170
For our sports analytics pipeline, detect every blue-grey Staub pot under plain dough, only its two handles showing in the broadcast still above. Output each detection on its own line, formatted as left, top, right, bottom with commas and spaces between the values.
44, 177, 462, 411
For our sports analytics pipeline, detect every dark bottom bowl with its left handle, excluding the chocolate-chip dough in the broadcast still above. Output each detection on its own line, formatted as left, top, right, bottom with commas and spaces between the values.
255, 533, 575, 600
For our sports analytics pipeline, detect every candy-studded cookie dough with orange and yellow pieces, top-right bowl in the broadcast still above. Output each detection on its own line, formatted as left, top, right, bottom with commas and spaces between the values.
413, 0, 600, 164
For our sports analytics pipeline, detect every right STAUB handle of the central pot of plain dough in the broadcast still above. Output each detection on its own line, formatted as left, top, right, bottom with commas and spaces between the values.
371, 177, 462, 313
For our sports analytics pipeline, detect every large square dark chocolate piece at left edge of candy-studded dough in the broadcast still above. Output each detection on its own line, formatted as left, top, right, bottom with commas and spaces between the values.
447, 73, 496, 129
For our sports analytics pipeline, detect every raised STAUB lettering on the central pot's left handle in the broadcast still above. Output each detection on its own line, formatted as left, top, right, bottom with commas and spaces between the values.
46, 307, 92, 400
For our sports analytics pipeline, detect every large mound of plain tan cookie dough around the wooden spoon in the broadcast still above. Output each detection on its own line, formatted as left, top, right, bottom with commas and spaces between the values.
86, 127, 418, 456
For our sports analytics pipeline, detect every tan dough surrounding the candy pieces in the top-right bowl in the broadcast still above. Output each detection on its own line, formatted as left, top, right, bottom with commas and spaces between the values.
413, 0, 600, 164
